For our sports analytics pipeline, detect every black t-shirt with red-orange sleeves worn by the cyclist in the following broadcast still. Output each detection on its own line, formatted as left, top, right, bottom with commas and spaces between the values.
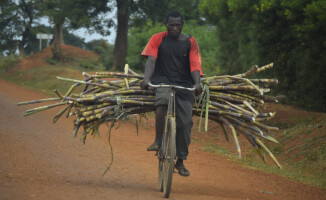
141, 32, 202, 87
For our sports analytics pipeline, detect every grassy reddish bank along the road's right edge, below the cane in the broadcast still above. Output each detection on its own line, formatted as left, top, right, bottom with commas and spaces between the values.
201, 115, 326, 189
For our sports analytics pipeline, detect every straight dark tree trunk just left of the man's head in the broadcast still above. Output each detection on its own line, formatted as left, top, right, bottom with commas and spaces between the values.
113, 0, 130, 70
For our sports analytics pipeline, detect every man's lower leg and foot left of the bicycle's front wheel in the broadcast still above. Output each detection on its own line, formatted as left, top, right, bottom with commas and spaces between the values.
147, 105, 167, 151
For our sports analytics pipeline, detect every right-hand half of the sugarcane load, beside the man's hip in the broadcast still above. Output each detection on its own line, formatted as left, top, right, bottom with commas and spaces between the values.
193, 63, 282, 168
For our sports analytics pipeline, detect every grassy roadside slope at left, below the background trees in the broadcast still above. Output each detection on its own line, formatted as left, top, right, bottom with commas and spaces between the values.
0, 56, 105, 96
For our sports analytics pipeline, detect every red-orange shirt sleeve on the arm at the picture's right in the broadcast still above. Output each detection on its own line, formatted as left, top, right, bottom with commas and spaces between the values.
189, 37, 203, 76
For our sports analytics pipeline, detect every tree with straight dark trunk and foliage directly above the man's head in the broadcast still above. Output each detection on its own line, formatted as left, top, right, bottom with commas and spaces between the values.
113, 0, 202, 69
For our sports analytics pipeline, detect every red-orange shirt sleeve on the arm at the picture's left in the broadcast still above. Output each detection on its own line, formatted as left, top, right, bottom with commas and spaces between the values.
140, 32, 167, 58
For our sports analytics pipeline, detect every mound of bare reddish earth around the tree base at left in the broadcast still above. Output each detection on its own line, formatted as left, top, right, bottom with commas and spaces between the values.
18, 44, 98, 70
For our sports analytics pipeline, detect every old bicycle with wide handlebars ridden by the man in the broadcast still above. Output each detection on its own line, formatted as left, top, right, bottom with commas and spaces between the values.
148, 83, 195, 198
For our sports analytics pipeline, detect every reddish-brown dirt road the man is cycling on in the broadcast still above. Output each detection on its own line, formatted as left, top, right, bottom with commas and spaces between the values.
0, 80, 326, 200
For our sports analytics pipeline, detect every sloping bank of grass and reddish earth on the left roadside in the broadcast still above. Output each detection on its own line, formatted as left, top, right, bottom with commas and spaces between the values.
0, 50, 104, 96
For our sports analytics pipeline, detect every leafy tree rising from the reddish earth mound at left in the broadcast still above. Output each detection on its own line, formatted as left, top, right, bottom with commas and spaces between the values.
39, 0, 113, 60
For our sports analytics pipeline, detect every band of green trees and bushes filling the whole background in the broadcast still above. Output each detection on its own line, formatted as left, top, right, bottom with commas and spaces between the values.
0, 0, 326, 112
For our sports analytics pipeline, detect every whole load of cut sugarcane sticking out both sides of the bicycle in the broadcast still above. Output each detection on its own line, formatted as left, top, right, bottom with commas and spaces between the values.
18, 64, 281, 168
